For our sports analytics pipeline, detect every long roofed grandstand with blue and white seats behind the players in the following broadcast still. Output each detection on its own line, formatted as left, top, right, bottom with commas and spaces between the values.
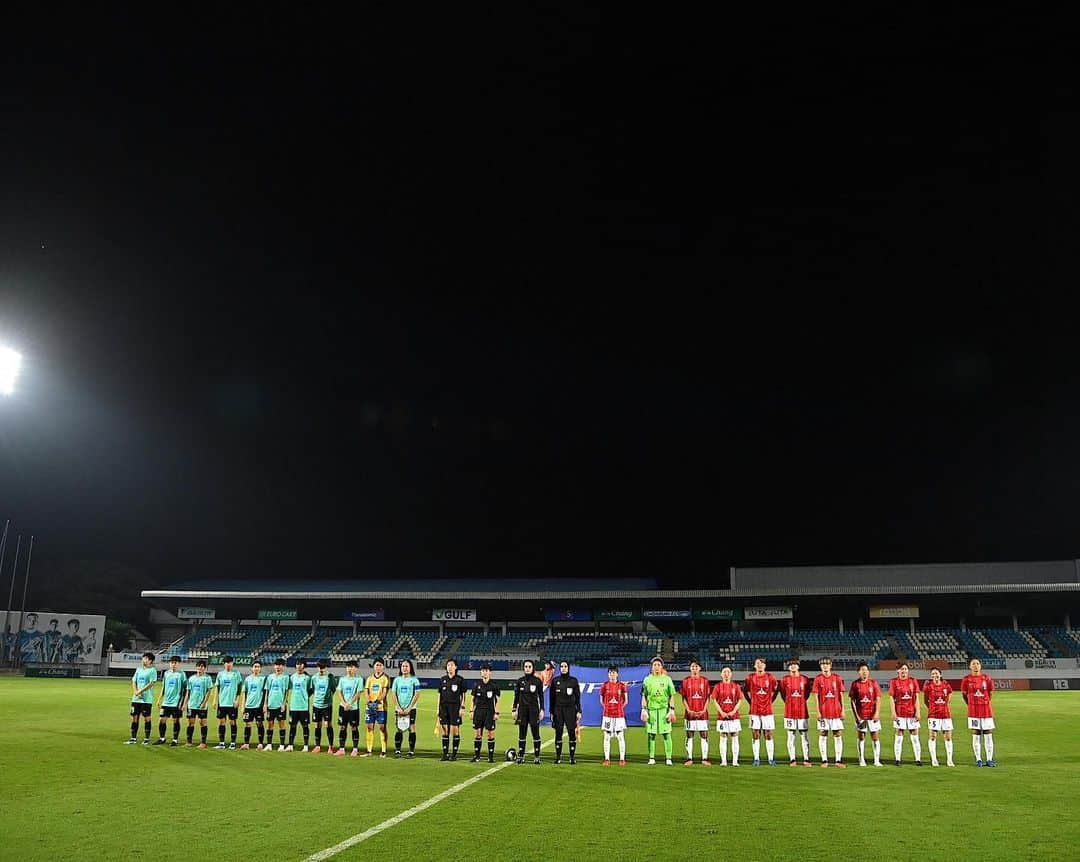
130, 561, 1080, 676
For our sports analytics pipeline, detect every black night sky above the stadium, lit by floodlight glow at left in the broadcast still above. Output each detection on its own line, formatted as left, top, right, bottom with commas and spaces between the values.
0, 4, 1080, 585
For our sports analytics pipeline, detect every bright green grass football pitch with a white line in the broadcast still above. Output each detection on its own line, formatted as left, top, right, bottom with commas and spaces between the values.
0, 677, 1080, 862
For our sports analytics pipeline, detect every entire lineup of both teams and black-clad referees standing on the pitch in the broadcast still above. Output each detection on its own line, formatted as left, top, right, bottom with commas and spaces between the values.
127, 652, 996, 768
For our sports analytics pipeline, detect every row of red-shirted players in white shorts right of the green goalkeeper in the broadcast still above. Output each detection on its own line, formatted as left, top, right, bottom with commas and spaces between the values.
673, 658, 997, 769
